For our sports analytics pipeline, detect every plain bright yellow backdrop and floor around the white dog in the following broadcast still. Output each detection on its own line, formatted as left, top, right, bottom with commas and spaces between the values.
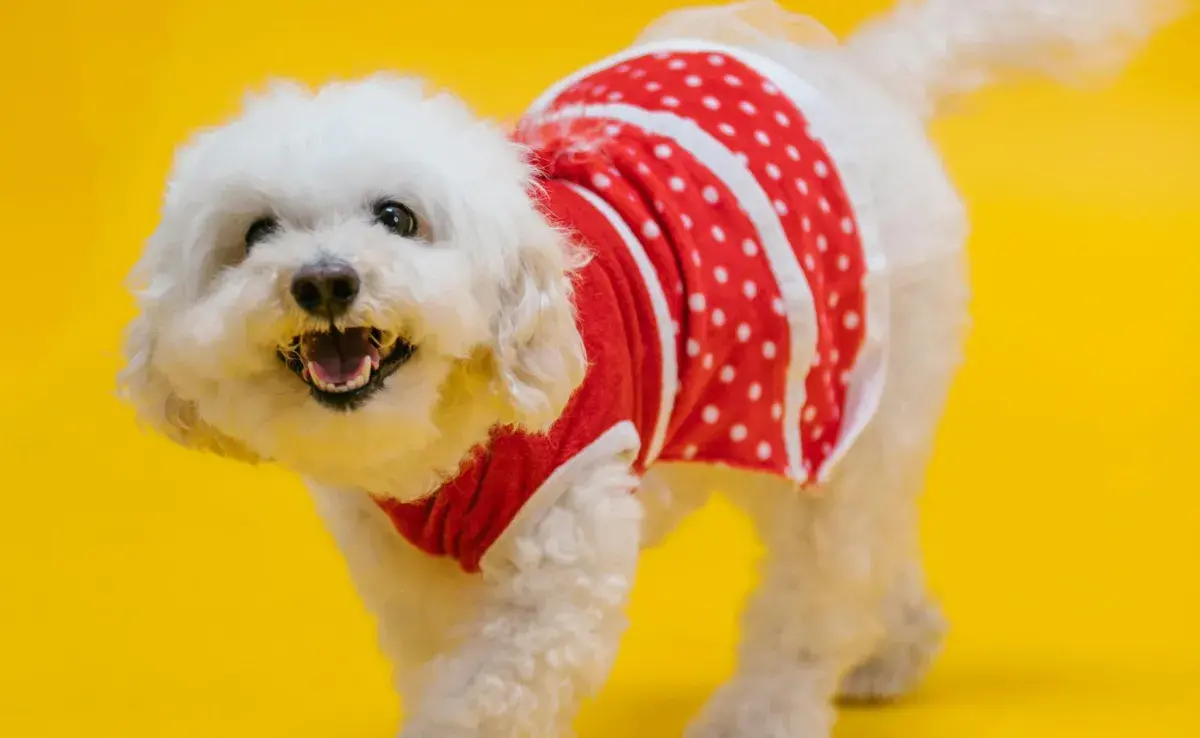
0, 0, 1200, 738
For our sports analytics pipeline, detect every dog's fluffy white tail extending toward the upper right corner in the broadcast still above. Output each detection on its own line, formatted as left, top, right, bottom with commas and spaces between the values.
844, 0, 1189, 116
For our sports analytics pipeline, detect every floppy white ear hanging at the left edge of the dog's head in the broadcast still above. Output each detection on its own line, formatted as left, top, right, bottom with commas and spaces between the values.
118, 232, 260, 463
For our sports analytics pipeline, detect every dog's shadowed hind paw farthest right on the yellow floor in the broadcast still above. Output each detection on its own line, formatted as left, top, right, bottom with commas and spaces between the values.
838, 604, 946, 703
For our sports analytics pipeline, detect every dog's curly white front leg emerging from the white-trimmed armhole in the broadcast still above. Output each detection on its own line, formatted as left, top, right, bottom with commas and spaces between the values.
401, 460, 641, 738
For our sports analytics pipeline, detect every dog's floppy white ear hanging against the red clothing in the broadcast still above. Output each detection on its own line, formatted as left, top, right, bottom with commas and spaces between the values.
493, 211, 587, 431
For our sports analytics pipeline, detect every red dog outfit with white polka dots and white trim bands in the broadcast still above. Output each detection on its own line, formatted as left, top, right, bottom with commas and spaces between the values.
377, 43, 886, 571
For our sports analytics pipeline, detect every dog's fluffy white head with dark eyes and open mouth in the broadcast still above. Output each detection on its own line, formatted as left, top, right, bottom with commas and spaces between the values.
122, 77, 583, 491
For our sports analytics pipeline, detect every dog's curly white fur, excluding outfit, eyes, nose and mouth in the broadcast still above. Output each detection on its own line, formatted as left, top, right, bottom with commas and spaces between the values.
121, 0, 1175, 738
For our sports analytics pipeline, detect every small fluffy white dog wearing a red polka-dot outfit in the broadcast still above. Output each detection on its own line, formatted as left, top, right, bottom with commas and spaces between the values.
122, 0, 1171, 738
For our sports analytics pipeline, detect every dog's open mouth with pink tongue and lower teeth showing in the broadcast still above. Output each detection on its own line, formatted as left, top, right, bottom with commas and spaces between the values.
278, 326, 416, 409
